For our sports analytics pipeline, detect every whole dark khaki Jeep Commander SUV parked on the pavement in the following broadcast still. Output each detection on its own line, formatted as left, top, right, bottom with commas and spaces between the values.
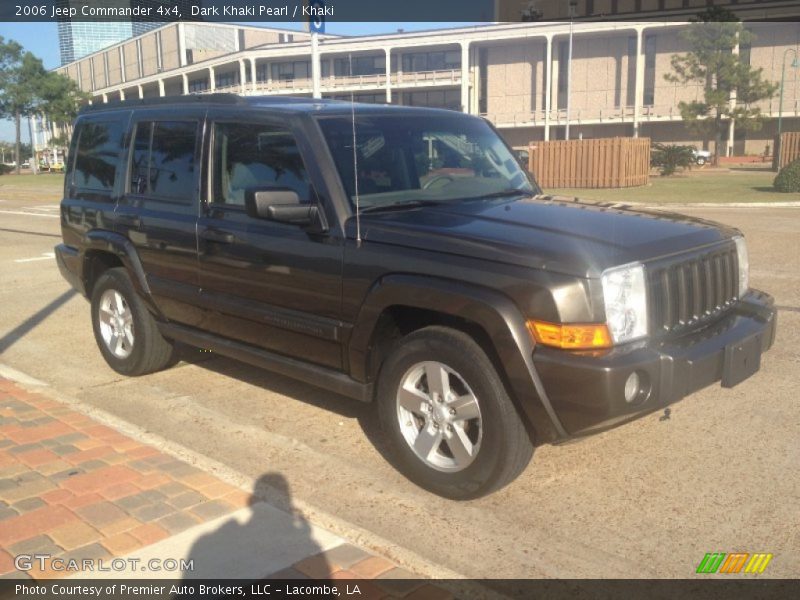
57, 95, 775, 499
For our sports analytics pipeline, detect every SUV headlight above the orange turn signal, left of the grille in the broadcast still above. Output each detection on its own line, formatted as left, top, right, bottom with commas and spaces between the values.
601, 263, 647, 344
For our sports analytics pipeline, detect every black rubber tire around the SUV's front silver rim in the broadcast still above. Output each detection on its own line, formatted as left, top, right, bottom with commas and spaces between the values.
377, 326, 533, 500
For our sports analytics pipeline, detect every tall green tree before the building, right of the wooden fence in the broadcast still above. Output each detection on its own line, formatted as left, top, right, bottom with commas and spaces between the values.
664, 7, 778, 165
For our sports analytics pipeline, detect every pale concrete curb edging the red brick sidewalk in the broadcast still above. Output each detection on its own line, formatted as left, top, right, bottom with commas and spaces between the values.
0, 363, 476, 584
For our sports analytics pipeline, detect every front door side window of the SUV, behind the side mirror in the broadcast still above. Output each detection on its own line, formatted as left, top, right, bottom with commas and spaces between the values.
214, 123, 311, 206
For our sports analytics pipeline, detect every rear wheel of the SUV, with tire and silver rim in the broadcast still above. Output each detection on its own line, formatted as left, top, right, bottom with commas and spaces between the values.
92, 267, 177, 375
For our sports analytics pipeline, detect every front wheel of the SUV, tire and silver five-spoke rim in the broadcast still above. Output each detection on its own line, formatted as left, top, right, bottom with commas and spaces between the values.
377, 326, 533, 500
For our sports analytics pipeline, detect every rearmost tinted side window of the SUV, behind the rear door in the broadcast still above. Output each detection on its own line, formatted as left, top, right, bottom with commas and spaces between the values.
72, 121, 123, 193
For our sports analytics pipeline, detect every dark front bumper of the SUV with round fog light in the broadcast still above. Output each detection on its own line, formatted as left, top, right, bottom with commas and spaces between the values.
533, 290, 777, 435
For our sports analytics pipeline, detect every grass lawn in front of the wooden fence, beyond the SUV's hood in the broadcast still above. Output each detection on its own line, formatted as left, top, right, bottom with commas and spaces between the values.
545, 168, 800, 204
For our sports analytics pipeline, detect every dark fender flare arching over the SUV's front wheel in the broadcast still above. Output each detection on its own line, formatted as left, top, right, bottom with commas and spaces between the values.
347, 274, 568, 443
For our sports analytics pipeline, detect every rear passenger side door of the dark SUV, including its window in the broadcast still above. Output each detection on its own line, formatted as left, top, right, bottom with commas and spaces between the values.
115, 108, 205, 325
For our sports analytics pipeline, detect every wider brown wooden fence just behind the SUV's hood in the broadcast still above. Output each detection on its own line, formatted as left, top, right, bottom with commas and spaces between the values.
528, 138, 650, 188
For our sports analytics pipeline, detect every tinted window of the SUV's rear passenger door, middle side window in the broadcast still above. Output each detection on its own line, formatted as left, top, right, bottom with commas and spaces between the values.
130, 121, 198, 204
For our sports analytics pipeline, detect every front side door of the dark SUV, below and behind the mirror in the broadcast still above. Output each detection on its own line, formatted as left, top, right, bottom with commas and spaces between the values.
198, 114, 343, 369
